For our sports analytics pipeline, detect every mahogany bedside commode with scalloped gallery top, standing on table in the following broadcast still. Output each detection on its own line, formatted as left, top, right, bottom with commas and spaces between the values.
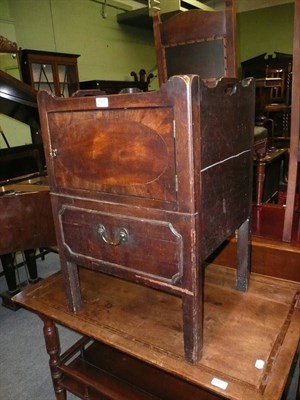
38, 76, 254, 362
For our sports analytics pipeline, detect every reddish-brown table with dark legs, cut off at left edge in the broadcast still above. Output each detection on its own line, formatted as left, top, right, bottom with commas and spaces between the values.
0, 178, 56, 304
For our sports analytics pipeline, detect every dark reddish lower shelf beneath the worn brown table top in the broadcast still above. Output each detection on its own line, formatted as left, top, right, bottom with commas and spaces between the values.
60, 342, 220, 400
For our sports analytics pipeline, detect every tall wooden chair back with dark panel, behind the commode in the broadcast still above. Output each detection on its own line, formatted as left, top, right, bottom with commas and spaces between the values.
153, 0, 237, 84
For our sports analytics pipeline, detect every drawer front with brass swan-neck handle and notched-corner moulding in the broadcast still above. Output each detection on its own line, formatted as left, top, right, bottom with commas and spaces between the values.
59, 206, 183, 284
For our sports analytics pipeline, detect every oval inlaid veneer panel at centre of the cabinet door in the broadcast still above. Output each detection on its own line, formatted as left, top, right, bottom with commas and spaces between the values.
50, 112, 168, 186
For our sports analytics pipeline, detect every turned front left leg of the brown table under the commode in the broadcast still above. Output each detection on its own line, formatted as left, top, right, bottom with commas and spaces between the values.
40, 316, 67, 400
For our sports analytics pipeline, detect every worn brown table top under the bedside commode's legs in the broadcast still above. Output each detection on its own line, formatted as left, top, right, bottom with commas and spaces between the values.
13, 264, 300, 400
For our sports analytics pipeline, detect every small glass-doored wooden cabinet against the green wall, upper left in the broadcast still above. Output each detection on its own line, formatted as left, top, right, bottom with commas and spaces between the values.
20, 49, 79, 97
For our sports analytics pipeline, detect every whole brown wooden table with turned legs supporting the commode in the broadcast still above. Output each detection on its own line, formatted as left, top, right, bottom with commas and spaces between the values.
14, 264, 300, 400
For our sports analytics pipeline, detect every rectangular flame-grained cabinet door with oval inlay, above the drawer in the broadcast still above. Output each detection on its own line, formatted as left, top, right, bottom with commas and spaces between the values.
48, 107, 176, 202
